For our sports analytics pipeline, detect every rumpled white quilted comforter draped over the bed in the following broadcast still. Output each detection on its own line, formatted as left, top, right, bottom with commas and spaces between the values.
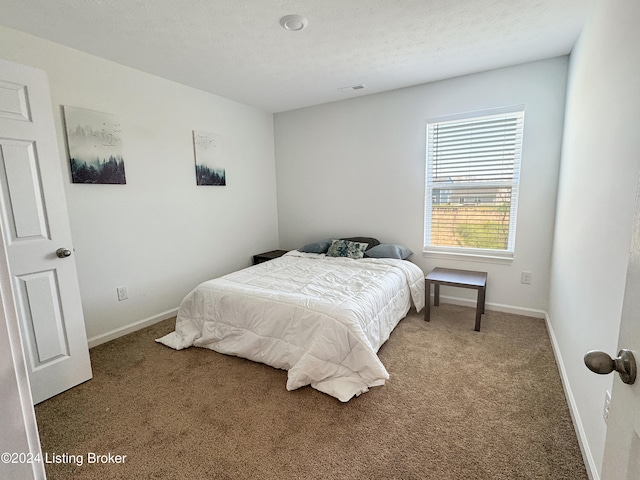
157, 251, 425, 402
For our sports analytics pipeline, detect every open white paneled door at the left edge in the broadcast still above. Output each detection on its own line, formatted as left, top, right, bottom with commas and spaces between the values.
0, 60, 92, 403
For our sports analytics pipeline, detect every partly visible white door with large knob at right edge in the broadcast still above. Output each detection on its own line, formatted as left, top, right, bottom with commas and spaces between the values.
601, 182, 640, 480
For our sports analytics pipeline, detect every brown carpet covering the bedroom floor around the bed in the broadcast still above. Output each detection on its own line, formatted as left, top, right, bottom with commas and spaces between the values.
36, 305, 588, 480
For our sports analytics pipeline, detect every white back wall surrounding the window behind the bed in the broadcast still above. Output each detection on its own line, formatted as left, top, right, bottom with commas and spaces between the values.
275, 57, 568, 311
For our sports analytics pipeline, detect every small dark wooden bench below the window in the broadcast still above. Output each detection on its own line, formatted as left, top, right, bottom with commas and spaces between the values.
424, 267, 487, 332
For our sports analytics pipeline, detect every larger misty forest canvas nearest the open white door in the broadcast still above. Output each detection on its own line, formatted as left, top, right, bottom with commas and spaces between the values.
64, 106, 127, 184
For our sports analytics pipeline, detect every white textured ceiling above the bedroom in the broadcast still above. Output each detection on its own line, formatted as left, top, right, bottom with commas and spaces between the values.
0, 0, 602, 112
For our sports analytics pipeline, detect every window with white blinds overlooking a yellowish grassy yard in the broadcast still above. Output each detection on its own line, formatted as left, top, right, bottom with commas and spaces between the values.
425, 107, 524, 258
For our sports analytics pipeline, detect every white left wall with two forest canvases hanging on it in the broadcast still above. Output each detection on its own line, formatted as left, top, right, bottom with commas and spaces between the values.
0, 26, 278, 343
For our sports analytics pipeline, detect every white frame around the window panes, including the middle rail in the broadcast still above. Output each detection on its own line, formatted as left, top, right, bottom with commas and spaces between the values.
423, 105, 525, 263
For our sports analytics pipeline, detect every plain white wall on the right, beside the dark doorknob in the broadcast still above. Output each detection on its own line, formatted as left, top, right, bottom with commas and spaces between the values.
549, 0, 640, 472
